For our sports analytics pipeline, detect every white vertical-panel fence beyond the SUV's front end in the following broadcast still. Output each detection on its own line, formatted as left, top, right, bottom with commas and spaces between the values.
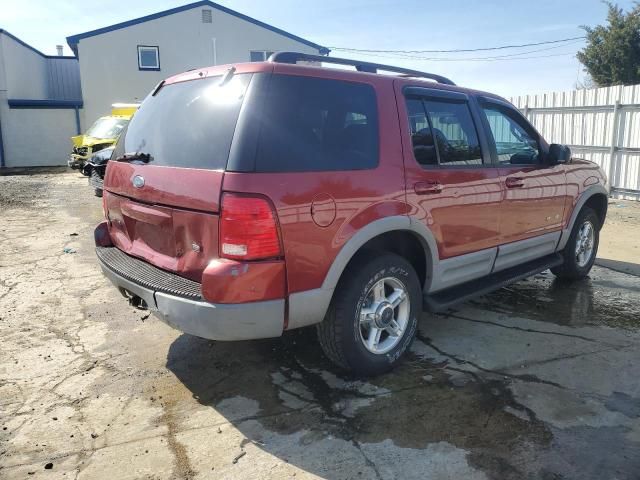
510, 85, 640, 200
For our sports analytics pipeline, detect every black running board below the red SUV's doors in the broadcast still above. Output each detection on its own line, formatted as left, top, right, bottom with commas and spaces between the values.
423, 253, 564, 313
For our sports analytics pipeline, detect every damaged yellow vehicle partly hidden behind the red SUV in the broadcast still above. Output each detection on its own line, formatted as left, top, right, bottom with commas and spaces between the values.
67, 103, 140, 173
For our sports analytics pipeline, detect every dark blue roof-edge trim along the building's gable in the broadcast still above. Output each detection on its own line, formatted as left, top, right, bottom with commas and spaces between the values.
67, 0, 330, 57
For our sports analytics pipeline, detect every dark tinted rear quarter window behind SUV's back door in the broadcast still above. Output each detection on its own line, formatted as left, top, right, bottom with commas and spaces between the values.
256, 75, 379, 172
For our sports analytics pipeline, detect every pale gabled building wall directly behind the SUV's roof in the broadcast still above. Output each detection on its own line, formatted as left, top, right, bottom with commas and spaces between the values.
78, 7, 318, 124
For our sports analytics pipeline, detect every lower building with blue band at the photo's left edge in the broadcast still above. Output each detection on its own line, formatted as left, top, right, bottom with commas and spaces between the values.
0, 30, 82, 167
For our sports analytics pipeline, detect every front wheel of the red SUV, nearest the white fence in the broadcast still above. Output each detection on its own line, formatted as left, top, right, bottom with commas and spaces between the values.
551, 207, 600, 280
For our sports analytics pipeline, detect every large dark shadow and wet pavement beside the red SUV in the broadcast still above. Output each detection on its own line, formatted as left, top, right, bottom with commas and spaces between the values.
167, 268, 640, 479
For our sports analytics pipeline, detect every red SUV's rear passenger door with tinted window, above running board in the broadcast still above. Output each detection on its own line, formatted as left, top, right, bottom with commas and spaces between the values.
396, 86, 502, 286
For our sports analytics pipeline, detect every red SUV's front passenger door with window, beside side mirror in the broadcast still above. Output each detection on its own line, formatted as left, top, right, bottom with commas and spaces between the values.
479, 99, 566, 248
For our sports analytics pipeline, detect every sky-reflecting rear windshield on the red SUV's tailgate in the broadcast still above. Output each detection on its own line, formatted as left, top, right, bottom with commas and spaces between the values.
118, 74, 251, 170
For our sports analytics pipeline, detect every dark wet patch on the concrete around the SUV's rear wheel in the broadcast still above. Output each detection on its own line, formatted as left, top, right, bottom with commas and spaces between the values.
167, 331, 552, 478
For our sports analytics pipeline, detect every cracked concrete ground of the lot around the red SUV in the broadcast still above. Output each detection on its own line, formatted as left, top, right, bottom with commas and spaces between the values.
0, 173, 640, 480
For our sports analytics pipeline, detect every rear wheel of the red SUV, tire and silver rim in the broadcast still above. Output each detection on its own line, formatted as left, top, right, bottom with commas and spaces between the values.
317, 252, 422, 375
